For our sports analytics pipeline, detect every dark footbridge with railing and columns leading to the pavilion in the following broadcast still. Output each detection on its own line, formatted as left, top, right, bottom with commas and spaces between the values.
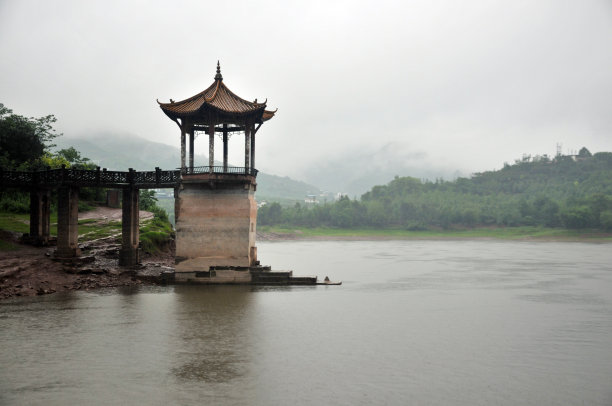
0, 166, 257, 266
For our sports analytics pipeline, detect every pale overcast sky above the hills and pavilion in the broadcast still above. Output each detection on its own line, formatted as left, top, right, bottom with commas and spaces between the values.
0, 0, 612, 179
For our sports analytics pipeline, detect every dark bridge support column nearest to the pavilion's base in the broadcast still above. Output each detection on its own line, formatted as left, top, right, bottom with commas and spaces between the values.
119, 187, 140, 266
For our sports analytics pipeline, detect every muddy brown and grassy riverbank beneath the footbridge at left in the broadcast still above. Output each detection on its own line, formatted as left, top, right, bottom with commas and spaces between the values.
0, 207, 174, 300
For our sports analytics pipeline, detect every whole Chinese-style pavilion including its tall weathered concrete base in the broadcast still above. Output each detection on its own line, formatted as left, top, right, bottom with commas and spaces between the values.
158, 62, 276, 283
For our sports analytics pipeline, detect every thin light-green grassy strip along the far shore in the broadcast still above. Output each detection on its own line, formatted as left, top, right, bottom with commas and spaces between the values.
258, 226, 612, 242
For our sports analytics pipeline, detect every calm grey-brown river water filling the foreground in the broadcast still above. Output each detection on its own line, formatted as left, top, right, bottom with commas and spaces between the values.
0, 241, 612, 405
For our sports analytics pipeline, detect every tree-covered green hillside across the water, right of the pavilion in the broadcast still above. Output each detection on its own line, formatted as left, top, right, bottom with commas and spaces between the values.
258, 148, 612, 230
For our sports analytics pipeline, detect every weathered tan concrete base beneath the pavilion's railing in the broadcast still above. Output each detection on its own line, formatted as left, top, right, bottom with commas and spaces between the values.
175, 174, 257, 283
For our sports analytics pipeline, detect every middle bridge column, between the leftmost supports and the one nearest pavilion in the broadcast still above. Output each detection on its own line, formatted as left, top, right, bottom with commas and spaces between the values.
55, 186, 81, 258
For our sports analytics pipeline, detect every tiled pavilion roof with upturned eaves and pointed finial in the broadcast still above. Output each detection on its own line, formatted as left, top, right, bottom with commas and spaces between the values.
157, 62, 276, 124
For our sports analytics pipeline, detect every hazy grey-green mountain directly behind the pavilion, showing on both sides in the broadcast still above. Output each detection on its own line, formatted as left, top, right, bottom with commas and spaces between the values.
54, 133, 320, 202
